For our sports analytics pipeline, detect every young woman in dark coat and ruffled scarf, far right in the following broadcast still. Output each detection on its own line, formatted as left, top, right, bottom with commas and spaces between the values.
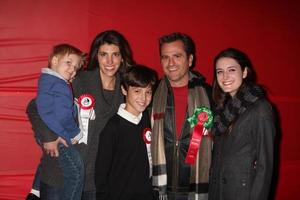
209, 48, 275, 200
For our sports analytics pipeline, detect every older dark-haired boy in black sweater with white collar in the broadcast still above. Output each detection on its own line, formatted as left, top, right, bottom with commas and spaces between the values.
95, 65, 157, 200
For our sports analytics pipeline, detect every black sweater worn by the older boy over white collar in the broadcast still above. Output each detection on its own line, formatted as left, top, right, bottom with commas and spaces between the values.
95, 114, 152, 200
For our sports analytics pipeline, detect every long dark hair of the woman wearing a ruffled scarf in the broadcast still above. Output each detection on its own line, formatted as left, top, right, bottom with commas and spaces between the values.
212, 48, 256, 107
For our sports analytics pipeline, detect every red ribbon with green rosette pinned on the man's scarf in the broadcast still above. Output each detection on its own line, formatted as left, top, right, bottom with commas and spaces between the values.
185, 107, 213, 165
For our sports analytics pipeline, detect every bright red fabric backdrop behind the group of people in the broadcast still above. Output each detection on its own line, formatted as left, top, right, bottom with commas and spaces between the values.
0, 0, 300, 200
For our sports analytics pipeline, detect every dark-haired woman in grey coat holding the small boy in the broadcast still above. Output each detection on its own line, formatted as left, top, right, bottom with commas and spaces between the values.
27, 30, 134, 200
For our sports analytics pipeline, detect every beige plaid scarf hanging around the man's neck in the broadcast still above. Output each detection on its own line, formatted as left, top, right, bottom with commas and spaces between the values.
151, 73, 212, 200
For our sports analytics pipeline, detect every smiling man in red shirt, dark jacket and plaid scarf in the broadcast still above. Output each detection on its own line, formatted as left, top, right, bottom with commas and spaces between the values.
151, 33, 212, 200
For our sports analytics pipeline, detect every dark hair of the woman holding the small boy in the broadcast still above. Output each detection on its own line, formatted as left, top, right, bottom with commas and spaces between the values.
87, 30, 135, 72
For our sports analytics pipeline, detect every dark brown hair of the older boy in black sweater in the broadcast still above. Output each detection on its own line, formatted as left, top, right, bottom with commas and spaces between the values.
122, 64, 157, 91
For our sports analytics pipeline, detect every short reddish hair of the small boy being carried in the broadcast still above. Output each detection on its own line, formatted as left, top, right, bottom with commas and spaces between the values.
48, 44, 86, 67
